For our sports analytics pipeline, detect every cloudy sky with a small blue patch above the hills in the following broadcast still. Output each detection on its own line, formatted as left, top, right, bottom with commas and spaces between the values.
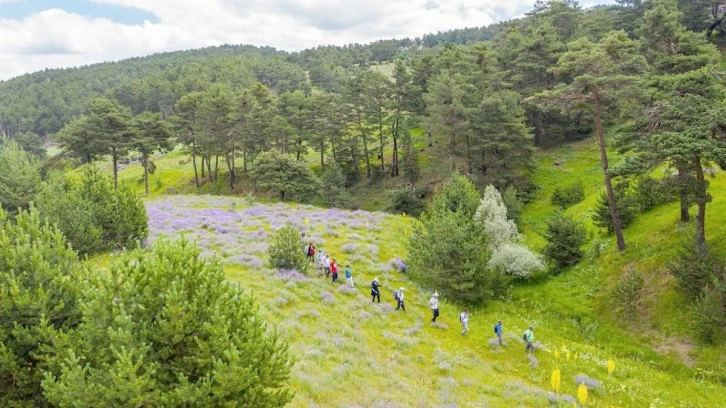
0, 0, 614, 80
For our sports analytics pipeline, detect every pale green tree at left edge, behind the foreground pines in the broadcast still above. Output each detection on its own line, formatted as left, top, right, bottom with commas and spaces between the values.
0, 136, 40, 213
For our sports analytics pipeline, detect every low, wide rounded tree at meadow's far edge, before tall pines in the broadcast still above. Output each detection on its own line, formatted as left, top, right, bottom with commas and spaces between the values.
250, 149, 318, 201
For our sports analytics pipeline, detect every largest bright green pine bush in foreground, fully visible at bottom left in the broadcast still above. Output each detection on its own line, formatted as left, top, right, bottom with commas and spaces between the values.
43, 239, 292, 407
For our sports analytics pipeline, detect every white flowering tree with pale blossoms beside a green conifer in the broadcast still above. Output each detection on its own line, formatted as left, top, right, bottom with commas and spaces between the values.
474, 185, 544, 277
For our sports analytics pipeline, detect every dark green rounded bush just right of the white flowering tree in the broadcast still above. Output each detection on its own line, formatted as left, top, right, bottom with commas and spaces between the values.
544, 212, 586, 272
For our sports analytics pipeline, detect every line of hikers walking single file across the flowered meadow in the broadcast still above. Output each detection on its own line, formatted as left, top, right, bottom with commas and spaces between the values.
306, 242, 535, 353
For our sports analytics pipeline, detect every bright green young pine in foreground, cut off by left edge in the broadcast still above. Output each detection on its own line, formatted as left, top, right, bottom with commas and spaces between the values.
0, 208, 81, 407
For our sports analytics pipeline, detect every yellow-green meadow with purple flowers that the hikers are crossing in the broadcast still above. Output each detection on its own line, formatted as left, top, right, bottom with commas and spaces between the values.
132, 190, 726, 407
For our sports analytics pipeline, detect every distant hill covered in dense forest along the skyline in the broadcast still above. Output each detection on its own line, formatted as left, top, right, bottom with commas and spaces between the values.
0, 0, 723, 137
